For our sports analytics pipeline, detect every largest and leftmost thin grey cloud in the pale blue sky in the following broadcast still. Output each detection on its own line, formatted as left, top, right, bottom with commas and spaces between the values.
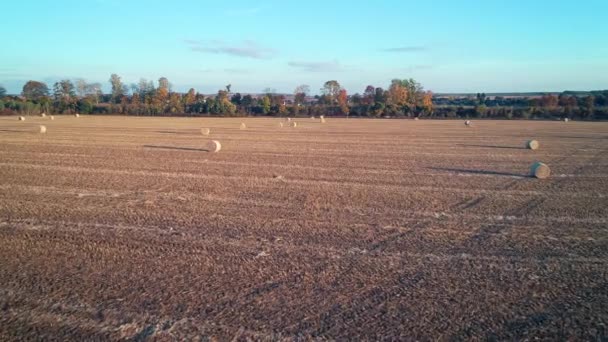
184, 39, 276, 59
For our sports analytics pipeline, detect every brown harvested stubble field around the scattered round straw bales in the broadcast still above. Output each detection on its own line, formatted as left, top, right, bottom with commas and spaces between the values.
0, 116, 608, 341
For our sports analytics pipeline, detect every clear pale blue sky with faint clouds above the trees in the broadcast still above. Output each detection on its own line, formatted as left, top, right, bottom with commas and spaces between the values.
0, 0, 608, 94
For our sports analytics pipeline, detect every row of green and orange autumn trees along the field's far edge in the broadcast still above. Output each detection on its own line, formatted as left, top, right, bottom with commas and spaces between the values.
0, 74, 608, 120
